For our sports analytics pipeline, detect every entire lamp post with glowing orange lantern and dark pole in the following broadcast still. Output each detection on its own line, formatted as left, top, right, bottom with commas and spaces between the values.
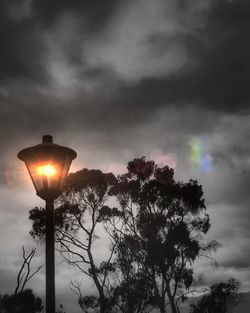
17, 135, 76, 313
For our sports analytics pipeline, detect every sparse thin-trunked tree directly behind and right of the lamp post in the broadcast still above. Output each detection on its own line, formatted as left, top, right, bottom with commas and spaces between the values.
30, 169, 115, 313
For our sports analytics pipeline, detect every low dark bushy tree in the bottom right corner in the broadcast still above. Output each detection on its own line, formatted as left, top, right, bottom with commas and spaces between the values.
191, 278, 240, 313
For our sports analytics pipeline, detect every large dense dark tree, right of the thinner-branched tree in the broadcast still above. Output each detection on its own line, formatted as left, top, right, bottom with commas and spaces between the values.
101, 158, 218, 313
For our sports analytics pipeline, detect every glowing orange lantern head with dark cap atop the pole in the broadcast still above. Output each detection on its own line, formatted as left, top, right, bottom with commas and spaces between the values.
17, 135, 76, 200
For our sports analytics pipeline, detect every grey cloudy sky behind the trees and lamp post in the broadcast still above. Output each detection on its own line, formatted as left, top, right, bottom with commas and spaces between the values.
0, 0, 250, 313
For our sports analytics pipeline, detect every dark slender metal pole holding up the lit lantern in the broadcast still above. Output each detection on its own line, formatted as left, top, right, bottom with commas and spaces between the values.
46, 200, 55, 313
